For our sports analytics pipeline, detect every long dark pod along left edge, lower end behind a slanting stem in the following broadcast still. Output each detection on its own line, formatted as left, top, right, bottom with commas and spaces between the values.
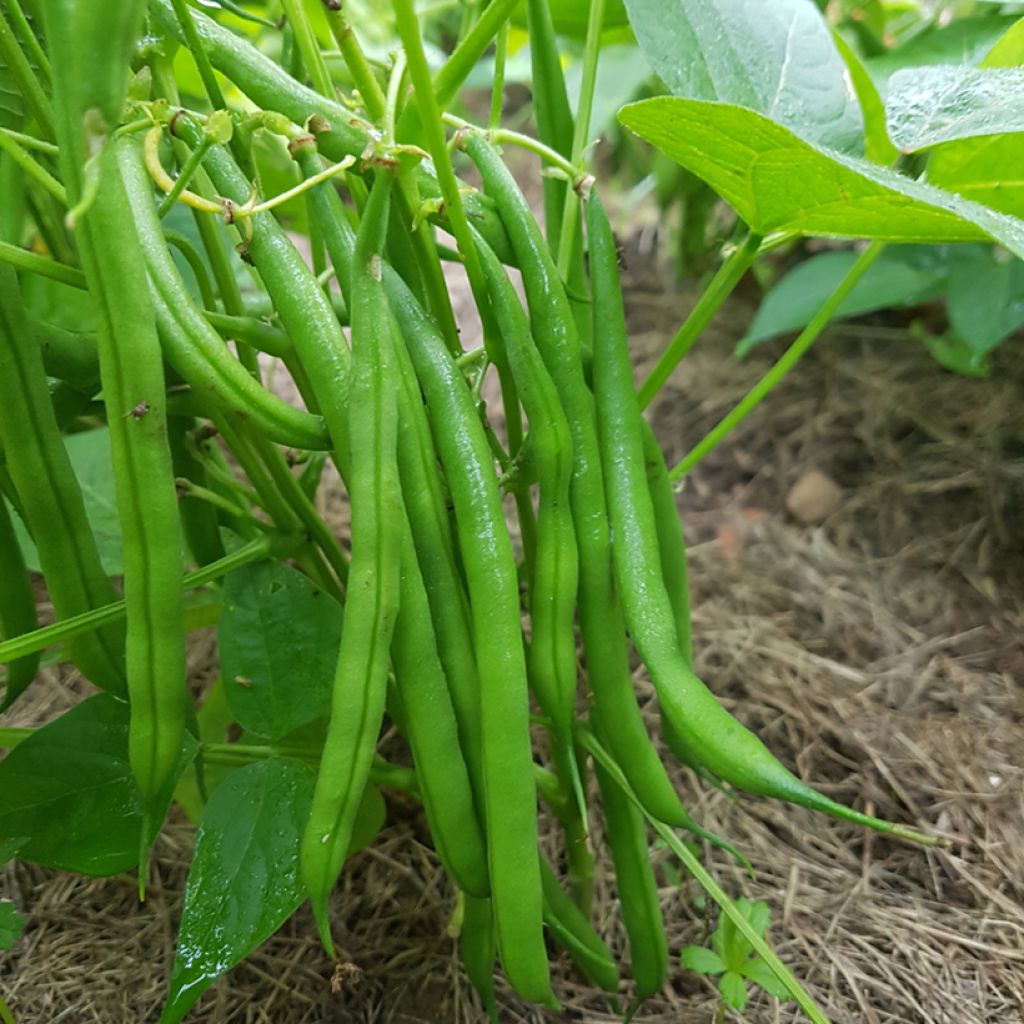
0, 266, 126, 696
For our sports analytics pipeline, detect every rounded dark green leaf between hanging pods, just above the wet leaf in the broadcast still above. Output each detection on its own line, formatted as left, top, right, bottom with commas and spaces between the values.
217, 561, 341, 739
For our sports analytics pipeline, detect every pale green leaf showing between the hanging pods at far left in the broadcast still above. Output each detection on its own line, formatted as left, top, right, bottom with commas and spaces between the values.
6, 427, 124, 575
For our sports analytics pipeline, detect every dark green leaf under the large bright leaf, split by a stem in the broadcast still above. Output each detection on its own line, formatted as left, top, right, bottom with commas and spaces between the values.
736, 246, 949, 355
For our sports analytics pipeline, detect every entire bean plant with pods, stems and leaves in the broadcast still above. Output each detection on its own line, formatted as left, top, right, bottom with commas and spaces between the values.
0, 0, 1024, 1024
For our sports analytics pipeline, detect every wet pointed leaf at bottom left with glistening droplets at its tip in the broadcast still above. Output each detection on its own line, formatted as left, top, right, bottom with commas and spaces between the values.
161, 761, 315, 1024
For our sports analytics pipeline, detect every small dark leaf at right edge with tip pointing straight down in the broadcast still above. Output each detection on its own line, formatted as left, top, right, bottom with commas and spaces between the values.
946, 250, 1024, 364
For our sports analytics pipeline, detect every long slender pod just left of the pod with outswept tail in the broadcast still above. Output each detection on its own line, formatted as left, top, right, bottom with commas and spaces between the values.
465, 134, 689, 826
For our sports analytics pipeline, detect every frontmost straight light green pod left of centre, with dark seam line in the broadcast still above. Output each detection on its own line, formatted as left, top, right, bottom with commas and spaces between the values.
300, 172, 401, 954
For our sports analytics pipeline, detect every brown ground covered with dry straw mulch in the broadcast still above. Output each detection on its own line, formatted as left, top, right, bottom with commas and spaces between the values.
0, 234, 1024, 1024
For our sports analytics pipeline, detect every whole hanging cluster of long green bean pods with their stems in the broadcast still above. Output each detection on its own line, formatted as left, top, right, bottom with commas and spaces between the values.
0, 0, 937, 1017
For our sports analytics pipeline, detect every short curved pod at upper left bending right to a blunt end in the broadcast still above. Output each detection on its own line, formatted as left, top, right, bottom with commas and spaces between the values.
119, 136, 330, 449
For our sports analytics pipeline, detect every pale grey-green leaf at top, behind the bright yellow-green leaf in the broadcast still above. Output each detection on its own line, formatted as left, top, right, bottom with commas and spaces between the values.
627, 0, 864, 153
